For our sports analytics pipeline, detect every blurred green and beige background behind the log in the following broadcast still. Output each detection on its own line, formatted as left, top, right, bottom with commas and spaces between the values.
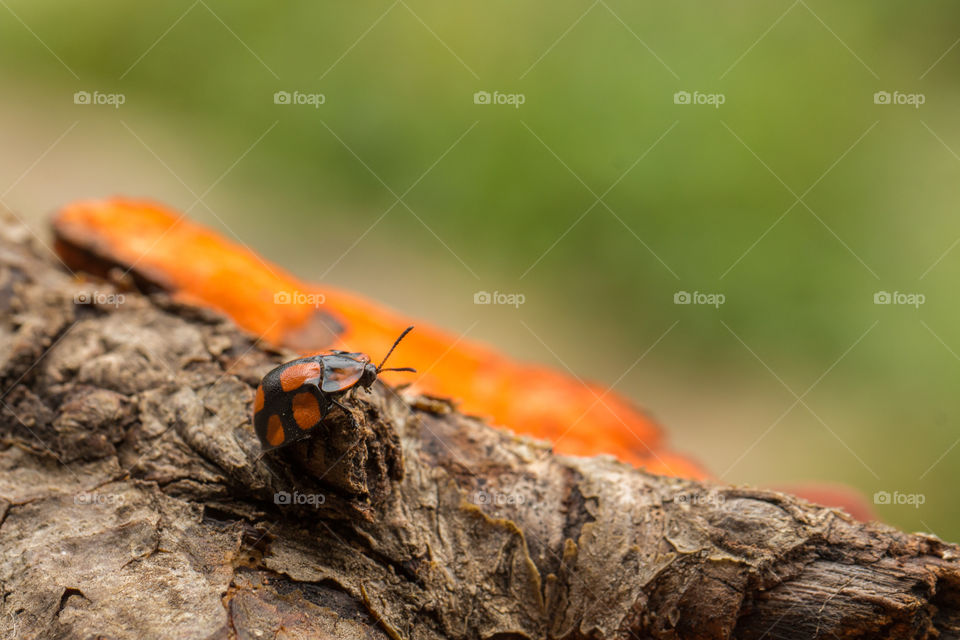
0, 0, 960, 541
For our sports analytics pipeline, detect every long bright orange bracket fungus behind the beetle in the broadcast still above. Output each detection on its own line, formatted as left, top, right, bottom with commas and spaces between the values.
53, 198, 705, 478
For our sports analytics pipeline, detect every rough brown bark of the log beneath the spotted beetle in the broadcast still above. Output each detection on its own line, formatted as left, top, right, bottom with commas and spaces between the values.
0, 216, 960, 640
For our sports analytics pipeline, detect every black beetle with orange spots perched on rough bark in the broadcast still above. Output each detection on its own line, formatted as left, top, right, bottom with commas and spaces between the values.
253, 327, 416, 453
